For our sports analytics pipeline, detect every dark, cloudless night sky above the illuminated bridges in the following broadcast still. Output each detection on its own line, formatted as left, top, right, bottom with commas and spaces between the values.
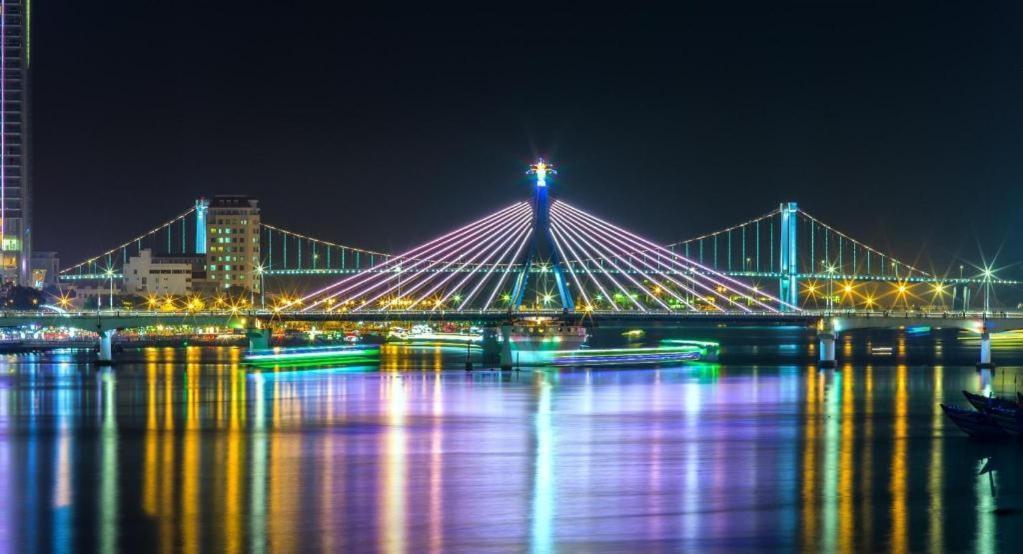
33, 0, 1023, 275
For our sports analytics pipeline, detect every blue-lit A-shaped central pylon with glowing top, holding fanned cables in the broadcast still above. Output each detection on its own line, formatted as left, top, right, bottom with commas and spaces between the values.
508, 157, 575, 312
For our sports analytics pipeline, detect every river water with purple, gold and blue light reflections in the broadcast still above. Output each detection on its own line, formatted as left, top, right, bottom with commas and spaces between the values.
0, 333, 1023, 552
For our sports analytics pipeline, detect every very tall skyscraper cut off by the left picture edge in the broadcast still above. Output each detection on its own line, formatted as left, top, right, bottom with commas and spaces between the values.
0, 0, 32, 286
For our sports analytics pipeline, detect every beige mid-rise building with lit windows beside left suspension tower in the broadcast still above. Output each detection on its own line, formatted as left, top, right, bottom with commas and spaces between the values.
206, 194, 260, 292
